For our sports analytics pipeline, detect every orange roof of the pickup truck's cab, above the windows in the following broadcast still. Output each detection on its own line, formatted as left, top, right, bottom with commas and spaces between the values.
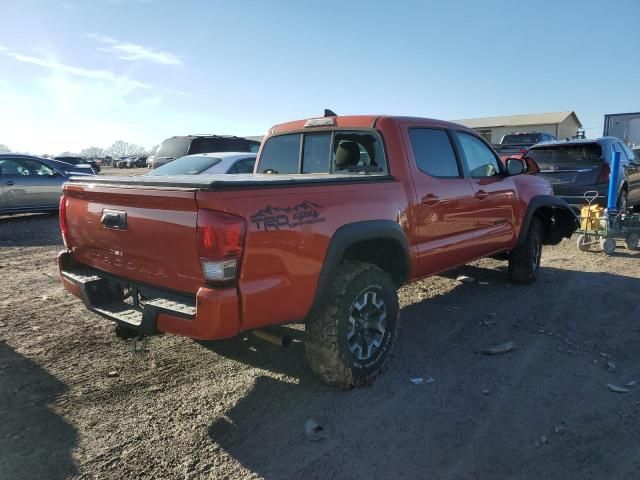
269, 115, 473, 135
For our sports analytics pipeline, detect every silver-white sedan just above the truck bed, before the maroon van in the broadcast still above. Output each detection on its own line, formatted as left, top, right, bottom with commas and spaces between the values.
146, 152, 257, 176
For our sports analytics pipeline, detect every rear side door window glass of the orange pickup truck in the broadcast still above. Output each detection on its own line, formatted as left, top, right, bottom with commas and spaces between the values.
409, 128, 461, 178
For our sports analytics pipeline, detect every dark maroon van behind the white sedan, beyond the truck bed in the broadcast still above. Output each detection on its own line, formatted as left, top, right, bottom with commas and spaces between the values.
151, 135, 260, 168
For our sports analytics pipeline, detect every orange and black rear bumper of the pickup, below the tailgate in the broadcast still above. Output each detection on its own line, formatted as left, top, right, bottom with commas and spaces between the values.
58, 251, 240, 340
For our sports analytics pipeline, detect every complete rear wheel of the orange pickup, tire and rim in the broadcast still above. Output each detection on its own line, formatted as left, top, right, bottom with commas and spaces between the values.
305, 262, 399, 388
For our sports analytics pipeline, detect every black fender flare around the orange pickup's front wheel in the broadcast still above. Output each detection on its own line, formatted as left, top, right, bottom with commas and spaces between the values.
518, 195, 580, 245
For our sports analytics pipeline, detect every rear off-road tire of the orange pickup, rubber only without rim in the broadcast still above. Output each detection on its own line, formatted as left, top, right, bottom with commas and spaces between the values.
305, 262, 399, 388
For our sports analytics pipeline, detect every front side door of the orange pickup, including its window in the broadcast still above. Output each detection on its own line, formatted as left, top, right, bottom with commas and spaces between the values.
455, 127, 518, 257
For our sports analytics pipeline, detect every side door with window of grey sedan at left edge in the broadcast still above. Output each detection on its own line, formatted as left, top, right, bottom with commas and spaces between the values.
0, 157, 64, 209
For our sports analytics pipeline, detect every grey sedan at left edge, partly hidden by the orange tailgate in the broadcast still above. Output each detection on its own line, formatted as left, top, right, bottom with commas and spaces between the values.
0, 153, 93, 214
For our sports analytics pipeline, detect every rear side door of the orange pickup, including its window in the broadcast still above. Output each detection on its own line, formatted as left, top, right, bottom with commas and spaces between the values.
404, 126, 484, 276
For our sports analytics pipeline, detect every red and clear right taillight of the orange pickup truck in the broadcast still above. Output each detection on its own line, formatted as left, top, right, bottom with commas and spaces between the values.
197, 210, 247, 284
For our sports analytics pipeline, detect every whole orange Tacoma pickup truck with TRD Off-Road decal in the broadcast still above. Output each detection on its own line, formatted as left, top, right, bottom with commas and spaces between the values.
58, 115, 578, 387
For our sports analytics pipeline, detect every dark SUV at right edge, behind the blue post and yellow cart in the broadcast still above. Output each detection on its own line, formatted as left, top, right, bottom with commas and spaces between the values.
525, 137, 640, 210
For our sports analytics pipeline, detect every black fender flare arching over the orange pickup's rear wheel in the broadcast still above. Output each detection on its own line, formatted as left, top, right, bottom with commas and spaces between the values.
311, 220, 411, 310
